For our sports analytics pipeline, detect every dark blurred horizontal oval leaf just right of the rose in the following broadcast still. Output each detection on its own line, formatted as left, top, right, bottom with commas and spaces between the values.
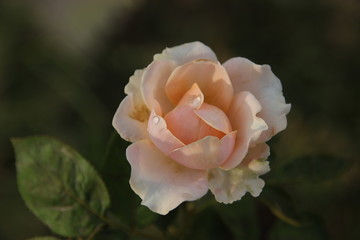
275, 155, 350, 182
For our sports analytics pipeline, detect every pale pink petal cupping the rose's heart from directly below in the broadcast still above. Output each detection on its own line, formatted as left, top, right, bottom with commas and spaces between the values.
169, 131, 236, 170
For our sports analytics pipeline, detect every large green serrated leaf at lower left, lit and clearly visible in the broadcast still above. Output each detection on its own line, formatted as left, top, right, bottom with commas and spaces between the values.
12, 136, 110, 237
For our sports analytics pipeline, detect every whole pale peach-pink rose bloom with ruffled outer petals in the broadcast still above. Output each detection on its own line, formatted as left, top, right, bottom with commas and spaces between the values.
113, 42, 290, 214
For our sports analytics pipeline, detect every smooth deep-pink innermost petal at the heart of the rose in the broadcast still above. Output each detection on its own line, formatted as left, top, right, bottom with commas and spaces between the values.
164, 105, 225, 144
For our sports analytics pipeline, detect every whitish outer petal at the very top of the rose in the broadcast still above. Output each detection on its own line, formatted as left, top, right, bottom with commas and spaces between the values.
154, 42, 217, 66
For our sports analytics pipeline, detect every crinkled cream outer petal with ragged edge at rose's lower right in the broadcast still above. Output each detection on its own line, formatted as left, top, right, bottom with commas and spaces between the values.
209, 144, 270, 203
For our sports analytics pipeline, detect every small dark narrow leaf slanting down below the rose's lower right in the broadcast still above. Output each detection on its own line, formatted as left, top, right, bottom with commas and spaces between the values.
259, 186, 302, 227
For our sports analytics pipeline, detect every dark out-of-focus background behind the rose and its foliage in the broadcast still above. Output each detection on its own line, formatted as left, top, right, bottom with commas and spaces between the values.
0, 0, 360, 240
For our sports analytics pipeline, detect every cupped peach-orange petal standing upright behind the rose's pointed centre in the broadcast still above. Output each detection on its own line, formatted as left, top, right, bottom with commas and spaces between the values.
165, 60, 233, 111
